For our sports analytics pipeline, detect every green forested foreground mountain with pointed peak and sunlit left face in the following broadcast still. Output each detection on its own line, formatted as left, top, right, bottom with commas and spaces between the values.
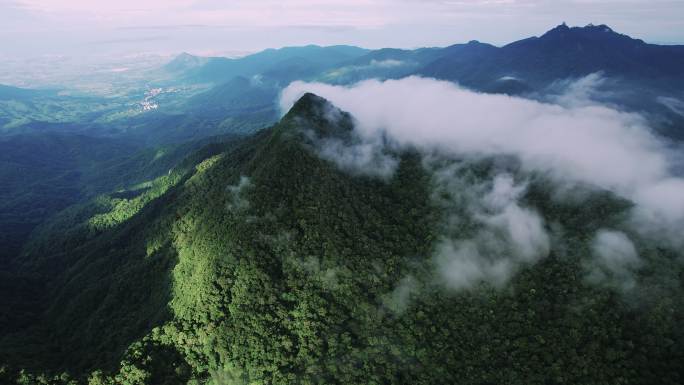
0, 95, 684, 385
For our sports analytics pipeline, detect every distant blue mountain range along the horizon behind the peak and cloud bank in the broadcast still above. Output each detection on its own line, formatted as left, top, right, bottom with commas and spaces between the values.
166, 24, 684, 139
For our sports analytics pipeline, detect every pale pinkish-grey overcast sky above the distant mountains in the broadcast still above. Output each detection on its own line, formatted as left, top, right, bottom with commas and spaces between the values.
0, 0, 684, 56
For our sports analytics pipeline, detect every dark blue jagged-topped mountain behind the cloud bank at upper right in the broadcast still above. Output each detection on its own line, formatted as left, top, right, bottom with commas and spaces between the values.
417, 24, 684, 140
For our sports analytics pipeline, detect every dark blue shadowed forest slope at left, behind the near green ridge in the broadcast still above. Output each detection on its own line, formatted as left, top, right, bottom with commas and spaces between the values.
0, 133, 242, 264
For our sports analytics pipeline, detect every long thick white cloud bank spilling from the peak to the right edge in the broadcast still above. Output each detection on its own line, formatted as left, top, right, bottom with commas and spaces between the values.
281, 77, 684, 230
